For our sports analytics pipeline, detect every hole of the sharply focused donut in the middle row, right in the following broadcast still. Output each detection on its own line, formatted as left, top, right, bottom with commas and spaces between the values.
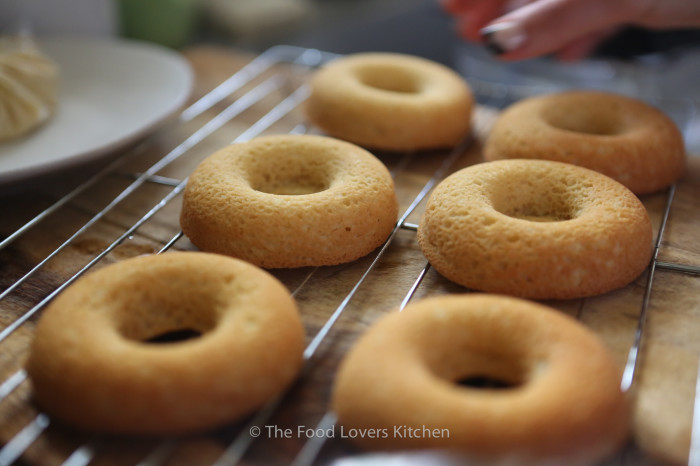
491, 179, 580, 222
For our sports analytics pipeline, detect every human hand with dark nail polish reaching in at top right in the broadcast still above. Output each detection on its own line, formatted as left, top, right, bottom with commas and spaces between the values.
442, 0, 700, 60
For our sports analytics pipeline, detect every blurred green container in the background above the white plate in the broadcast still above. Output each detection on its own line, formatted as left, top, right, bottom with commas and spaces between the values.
117, 0, 197, 48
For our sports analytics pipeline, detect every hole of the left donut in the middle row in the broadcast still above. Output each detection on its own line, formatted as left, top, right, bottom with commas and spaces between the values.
248, 156, 331, 196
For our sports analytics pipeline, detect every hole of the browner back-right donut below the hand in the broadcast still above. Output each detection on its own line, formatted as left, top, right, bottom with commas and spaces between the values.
542, 102, 627, 136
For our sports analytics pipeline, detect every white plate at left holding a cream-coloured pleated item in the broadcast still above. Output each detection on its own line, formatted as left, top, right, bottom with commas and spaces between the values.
0, 38, 193, 183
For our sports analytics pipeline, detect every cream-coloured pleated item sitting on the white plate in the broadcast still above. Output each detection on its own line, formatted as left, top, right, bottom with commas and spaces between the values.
0, 35, 59, 141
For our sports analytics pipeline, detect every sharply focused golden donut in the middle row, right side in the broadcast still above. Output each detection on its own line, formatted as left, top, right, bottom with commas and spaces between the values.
418, 160, 652, 299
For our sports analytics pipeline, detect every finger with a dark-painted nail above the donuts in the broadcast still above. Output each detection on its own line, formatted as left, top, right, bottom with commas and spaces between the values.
481, 0, 628, 60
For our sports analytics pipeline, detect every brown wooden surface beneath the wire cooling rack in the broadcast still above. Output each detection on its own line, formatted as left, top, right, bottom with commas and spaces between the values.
0, 47, 700, 465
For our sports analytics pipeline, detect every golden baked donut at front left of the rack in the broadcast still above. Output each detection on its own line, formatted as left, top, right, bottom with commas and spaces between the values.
26, 252, 304, 435
